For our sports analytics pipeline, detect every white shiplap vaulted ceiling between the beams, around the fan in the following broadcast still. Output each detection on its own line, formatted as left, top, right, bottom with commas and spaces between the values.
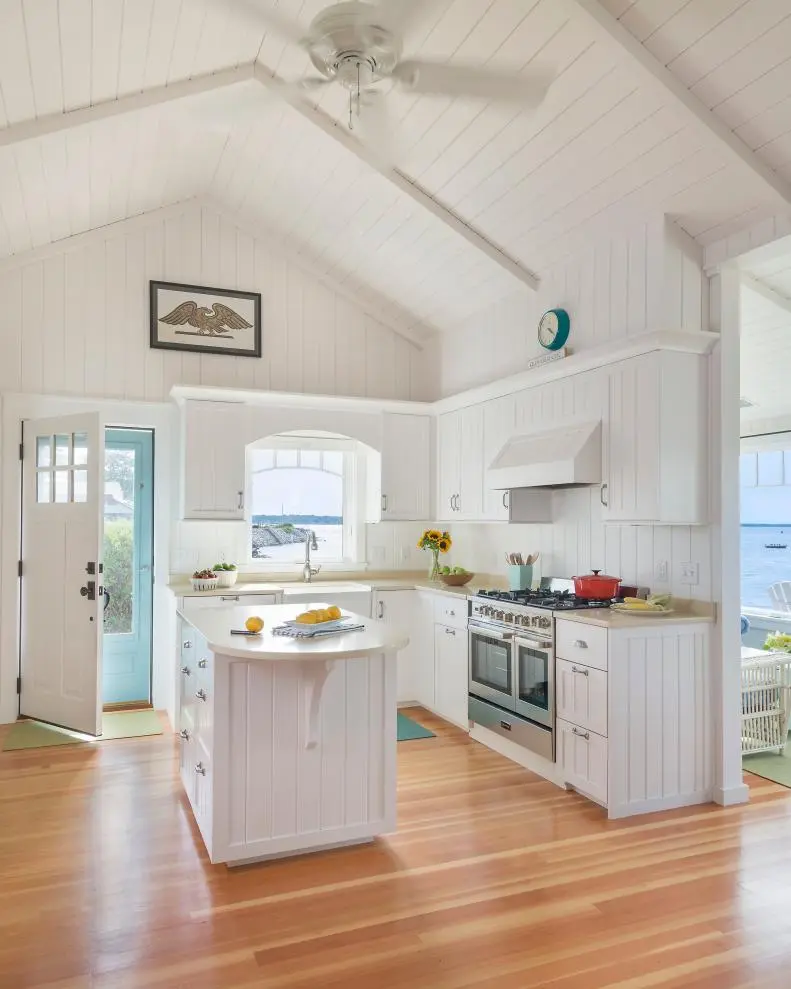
0, 0, 791, 329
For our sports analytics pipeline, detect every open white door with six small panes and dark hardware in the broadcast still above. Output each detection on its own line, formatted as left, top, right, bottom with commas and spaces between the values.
20, 412, 104, 735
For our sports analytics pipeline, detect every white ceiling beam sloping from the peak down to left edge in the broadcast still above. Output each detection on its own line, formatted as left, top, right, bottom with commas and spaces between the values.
0, 63, 253, 147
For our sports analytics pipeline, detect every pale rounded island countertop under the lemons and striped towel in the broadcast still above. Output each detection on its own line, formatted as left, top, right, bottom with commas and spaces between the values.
179, 599, 409, 662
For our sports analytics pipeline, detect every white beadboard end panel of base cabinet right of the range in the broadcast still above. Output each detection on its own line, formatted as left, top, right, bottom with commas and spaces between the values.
607, 620, 714, 818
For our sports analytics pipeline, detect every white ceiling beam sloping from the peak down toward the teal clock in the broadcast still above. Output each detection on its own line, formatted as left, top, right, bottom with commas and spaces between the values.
255, 63, 540, 292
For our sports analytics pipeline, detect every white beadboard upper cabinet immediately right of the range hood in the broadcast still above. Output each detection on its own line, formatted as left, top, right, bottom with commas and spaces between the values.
601, 351, 708, 525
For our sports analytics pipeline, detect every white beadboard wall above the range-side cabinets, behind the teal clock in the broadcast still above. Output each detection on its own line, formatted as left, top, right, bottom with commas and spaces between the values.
441, 217, 708, 396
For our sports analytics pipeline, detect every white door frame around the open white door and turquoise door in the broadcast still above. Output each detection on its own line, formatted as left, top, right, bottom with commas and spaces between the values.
0, 394, 178, 724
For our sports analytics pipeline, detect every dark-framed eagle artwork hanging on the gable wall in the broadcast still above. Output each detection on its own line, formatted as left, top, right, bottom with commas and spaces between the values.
150, 281, 261, 357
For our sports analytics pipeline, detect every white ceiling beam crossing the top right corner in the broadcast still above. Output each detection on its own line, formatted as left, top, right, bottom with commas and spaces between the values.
574, 0, 791, 207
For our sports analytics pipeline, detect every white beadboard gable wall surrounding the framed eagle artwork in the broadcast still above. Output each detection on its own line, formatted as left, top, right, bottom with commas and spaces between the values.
0, 202, 433, 401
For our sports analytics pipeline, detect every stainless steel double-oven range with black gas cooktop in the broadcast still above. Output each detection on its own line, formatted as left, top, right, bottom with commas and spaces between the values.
468, 578, 611, 761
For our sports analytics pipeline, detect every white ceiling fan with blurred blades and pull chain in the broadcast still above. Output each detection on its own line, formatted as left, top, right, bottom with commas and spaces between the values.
226, 0, 552, 143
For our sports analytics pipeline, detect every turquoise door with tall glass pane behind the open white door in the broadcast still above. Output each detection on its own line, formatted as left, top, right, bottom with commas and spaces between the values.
102, 429, 154, 704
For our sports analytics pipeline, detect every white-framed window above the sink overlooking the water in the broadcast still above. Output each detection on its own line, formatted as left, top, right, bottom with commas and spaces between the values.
247, 446, 358, 565
